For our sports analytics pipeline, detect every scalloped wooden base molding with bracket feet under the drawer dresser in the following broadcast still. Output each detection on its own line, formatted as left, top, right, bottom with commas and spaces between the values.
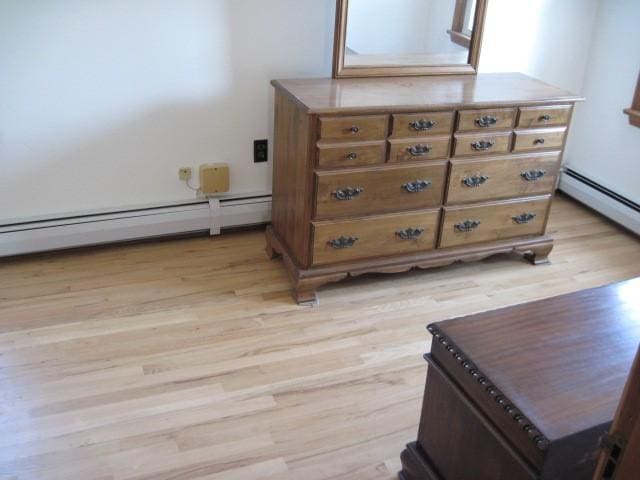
266, 226, 553, 305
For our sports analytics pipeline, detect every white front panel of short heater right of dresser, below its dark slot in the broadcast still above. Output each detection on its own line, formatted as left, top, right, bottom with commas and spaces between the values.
559, 171, 640, 235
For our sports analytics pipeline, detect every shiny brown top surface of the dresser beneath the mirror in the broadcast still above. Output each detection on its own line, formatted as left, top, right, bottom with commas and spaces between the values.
271, 73, 582, 114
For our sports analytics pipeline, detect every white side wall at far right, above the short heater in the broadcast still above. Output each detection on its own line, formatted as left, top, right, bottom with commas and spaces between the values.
566, 0, 640, 203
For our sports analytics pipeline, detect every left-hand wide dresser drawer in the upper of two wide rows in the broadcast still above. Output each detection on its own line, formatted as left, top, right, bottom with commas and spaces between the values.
315, 162, 447, 218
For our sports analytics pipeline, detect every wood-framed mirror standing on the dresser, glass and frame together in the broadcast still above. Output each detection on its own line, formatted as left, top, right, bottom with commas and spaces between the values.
334, 0, 487, 77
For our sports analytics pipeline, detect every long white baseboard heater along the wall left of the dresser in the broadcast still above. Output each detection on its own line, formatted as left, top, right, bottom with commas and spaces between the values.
0, 195, 271, 257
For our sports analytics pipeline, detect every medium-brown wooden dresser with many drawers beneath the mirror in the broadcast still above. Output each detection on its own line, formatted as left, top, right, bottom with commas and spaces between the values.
267, 74, 580, 302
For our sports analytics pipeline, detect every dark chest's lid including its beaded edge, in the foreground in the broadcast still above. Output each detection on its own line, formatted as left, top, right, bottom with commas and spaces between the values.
428, 279, 640, 468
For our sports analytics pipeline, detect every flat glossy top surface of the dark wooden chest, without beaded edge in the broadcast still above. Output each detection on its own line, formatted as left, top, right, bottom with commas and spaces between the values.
434, 278, 640, 440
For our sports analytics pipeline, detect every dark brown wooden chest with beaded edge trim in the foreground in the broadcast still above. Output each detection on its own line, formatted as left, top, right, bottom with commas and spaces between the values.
400, 279, 640, 480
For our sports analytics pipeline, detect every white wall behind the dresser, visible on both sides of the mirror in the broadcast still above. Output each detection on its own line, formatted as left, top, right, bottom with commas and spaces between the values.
0, 0, 608, 223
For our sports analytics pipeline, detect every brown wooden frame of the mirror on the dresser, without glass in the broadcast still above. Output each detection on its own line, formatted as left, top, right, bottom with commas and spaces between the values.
333, 0, 489, 78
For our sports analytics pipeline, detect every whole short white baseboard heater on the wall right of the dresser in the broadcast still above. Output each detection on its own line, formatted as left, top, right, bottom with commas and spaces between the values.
559, 168, 640, 235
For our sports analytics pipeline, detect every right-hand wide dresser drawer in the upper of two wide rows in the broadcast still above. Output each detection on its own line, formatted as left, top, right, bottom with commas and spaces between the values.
447, 152, 560, 204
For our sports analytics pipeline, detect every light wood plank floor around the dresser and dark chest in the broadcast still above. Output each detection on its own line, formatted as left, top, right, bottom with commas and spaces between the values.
0, 197, 640, 480
